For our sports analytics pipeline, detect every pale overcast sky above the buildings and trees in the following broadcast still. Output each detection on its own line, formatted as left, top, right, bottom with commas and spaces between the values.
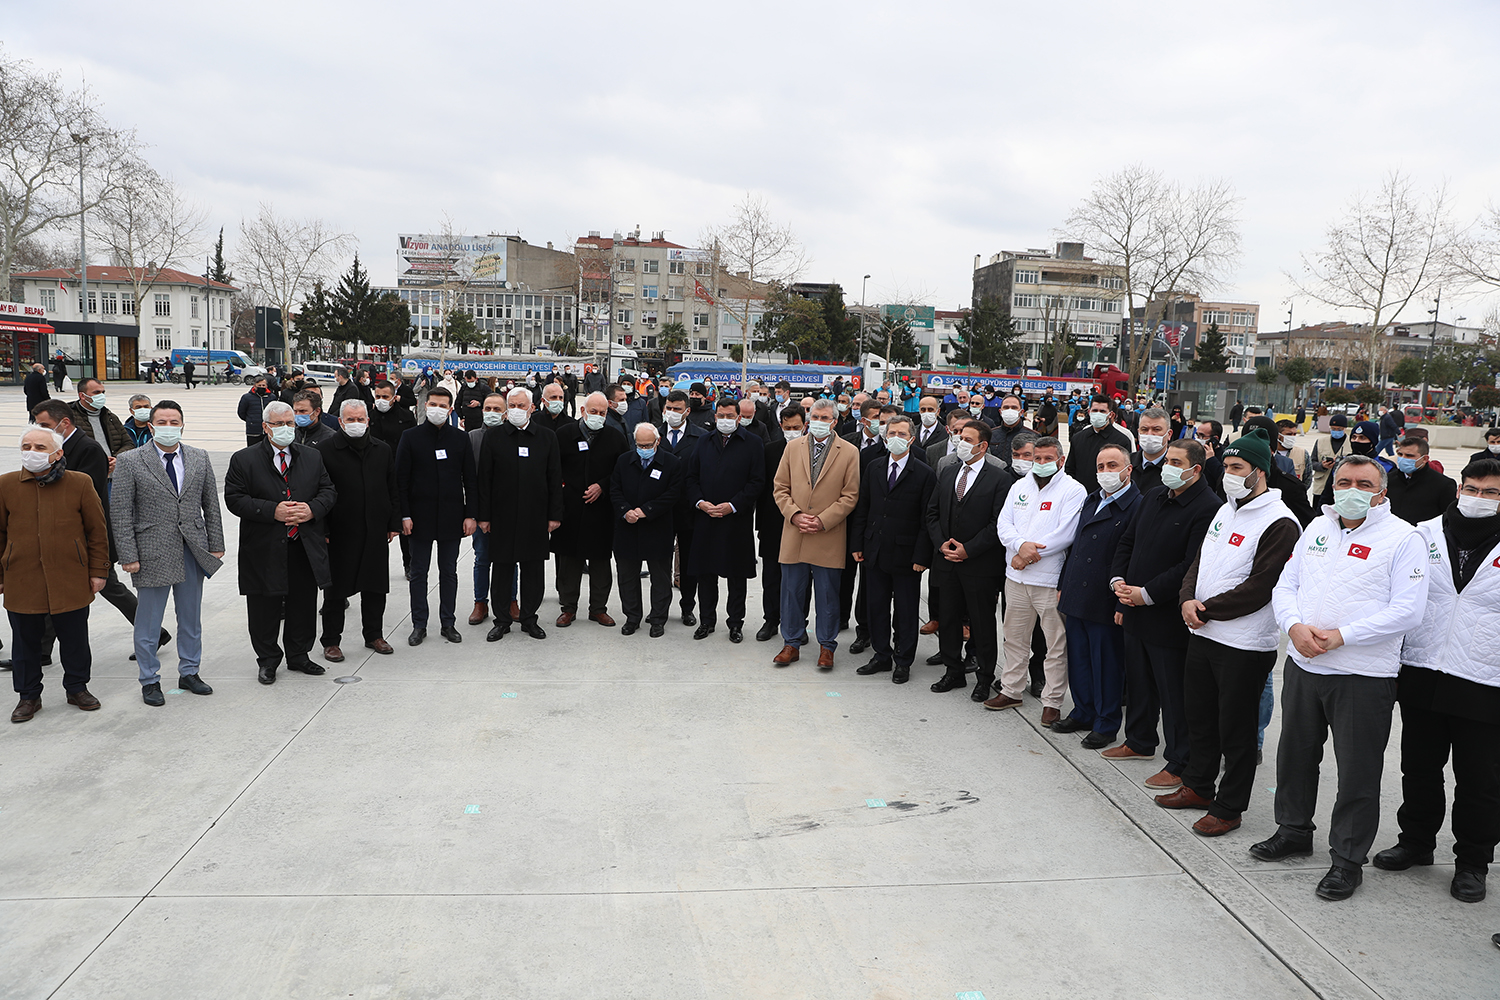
11, 0, 1500, 328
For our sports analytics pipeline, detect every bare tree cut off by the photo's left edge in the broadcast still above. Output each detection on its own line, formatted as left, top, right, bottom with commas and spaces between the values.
0, 54, 137, 294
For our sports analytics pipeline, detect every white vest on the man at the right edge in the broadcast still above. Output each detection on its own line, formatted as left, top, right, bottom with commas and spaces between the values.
1401, 516, 1500, 688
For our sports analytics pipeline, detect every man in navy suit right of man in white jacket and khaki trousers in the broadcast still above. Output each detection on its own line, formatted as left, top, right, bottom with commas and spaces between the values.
1052, 444, 1140, 750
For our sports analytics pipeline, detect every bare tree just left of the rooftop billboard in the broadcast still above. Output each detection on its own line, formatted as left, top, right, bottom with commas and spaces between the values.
237, 202, 354, 355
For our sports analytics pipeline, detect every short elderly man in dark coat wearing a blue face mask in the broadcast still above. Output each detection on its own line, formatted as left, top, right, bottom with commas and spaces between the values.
609, 423, 683, 639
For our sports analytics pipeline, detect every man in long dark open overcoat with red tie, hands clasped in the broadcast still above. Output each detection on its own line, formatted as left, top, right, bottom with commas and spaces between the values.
224, 402, 338, 684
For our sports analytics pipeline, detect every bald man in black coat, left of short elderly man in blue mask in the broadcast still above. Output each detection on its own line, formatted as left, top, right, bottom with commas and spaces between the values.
552, 393, 627, 628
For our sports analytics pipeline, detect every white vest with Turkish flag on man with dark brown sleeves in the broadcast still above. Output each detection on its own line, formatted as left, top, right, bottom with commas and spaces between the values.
1193, 489, 1298, 652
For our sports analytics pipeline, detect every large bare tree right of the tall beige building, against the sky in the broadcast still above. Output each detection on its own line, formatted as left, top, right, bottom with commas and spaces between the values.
1059, 163, 1241, 381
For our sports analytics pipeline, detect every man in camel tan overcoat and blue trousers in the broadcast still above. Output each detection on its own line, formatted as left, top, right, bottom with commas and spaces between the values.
771, 399, 860, 670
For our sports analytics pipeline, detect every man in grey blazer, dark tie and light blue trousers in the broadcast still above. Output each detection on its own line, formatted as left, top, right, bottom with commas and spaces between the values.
110, 399, 224, 708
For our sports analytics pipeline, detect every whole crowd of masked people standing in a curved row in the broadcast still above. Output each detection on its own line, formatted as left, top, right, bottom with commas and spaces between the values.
0, 370, 1500, 923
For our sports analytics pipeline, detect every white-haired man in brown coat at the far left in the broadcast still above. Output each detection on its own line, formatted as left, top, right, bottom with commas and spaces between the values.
0, 426, 110, 723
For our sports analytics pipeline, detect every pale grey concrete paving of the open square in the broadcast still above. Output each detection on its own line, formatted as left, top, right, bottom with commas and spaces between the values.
0, 387, 1500, 1000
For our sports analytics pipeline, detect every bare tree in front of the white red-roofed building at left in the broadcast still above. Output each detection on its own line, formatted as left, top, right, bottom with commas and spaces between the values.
89, 160, 212, 343
